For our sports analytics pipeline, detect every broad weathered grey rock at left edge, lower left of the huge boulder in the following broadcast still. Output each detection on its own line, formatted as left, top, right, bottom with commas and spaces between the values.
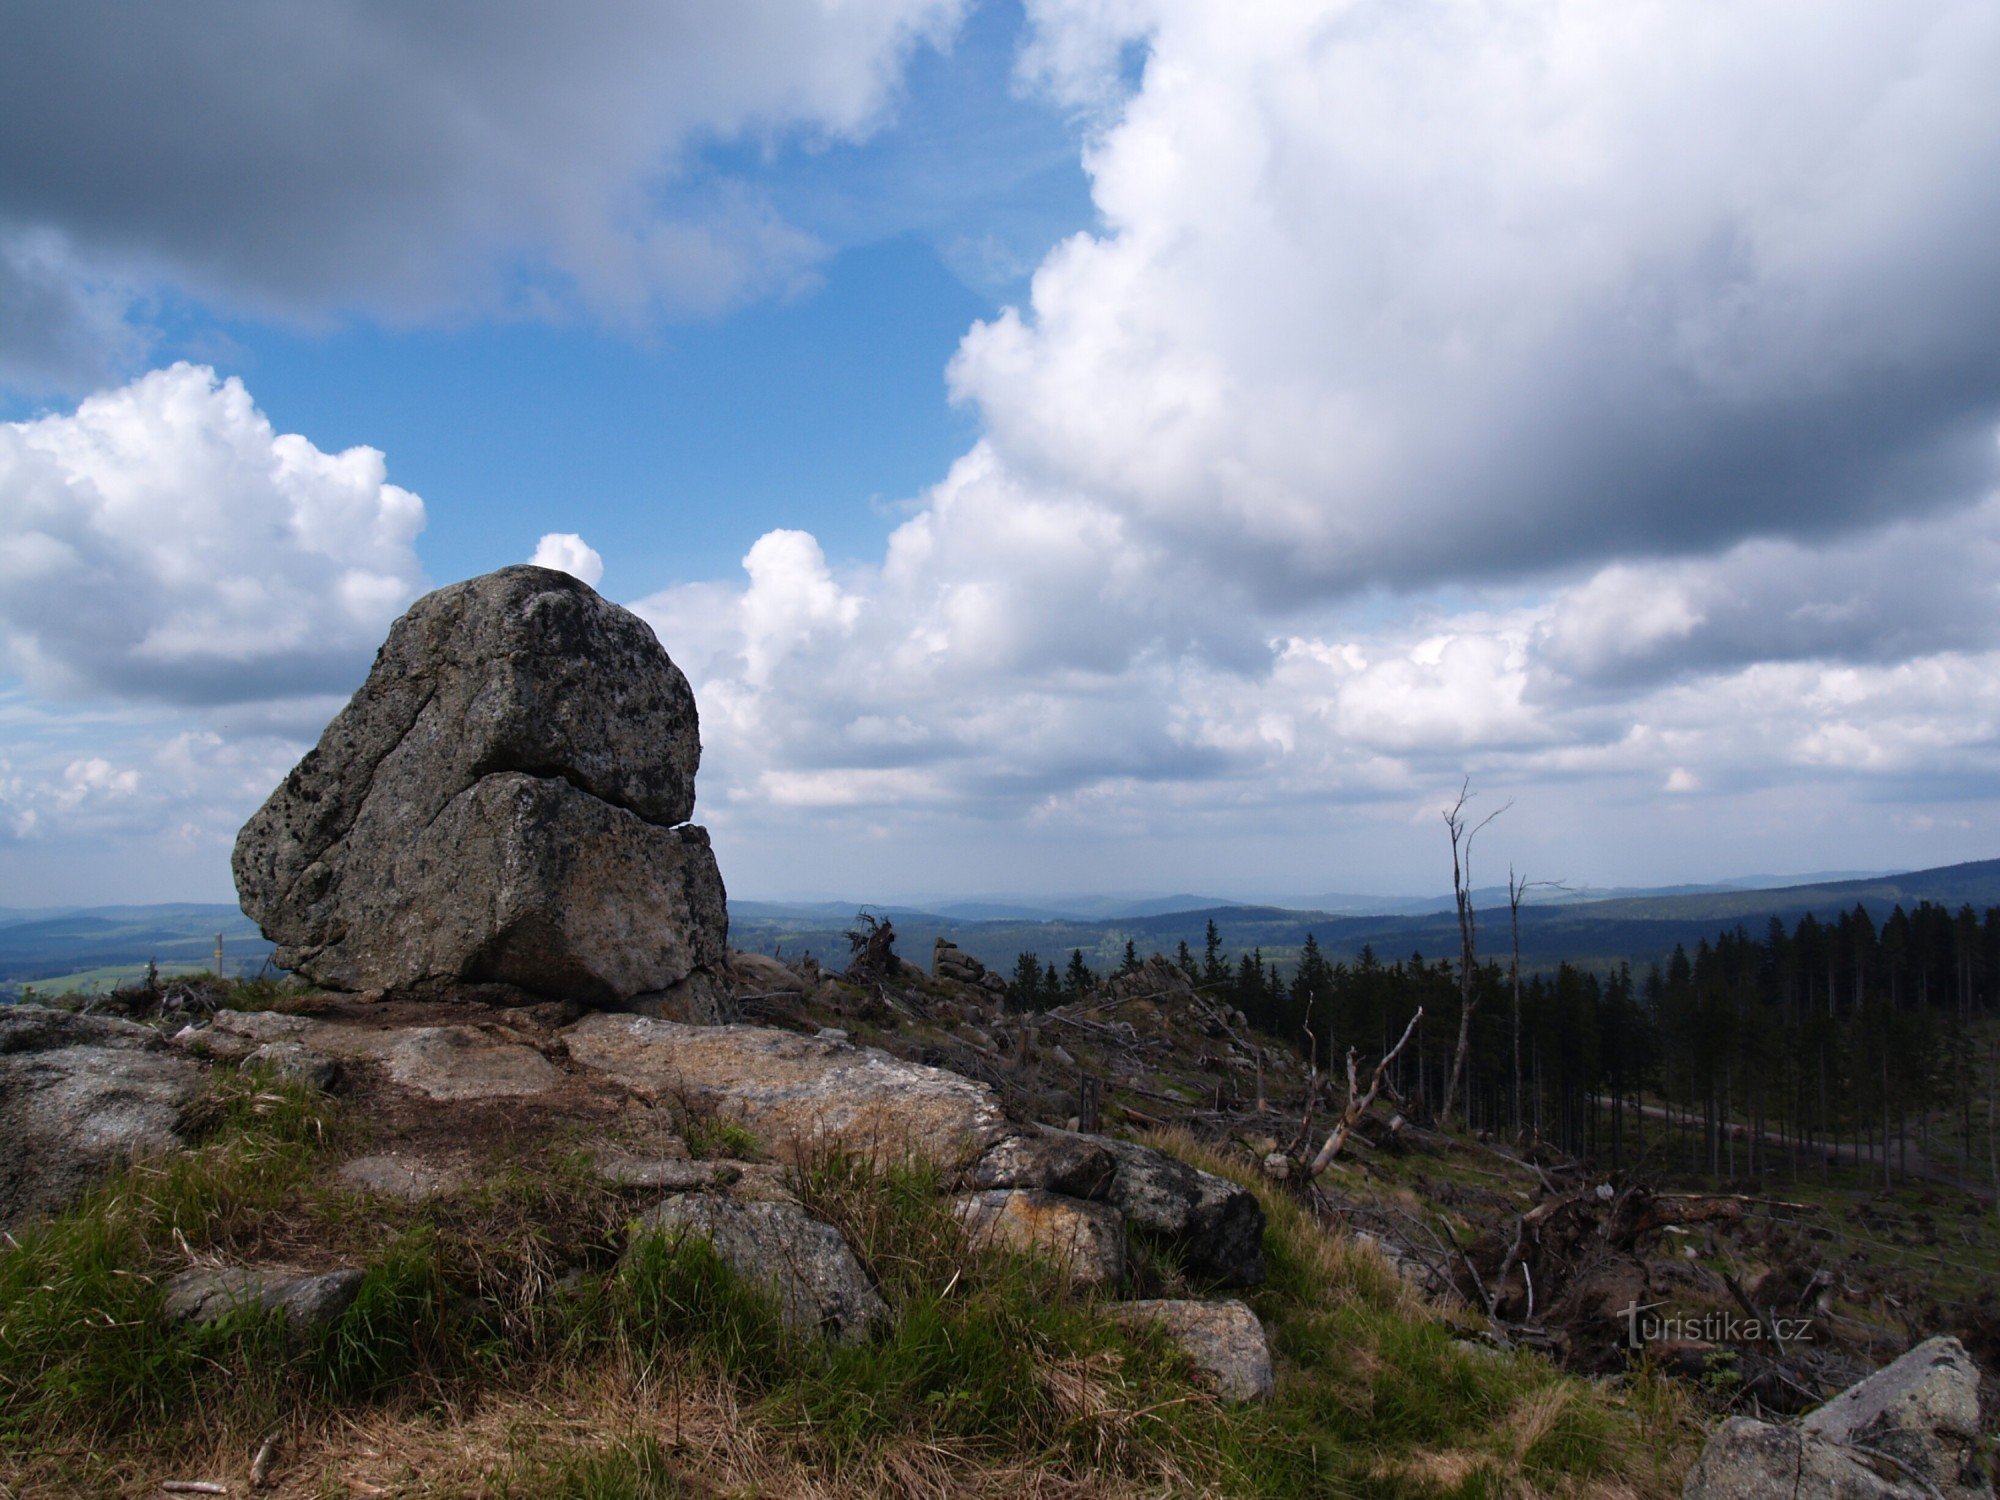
0, 1004, 208, 1230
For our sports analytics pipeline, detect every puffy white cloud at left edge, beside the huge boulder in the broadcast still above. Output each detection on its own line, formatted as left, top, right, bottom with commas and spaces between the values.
0, 364, 424, 704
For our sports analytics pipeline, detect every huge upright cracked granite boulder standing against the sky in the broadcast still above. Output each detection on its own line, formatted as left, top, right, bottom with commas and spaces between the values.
234, 566, 728, 1002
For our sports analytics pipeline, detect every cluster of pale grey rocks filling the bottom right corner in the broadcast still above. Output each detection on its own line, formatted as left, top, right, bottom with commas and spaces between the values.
1682, 1338, 1994, 1500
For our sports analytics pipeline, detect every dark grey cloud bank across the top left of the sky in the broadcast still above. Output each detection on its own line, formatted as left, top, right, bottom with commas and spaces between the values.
0, 0, 964, 380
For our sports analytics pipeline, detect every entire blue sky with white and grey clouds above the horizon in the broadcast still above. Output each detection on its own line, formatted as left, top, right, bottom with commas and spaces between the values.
0, 0, 2000, 906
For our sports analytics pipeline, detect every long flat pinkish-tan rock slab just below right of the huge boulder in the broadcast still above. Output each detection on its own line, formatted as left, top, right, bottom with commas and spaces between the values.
562, 1012, 1014, 1166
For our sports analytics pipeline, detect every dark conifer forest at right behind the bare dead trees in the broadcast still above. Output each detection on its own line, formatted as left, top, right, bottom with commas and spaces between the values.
1010, 902, 2000, 1186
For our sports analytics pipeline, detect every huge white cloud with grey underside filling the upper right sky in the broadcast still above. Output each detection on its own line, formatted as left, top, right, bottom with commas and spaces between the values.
952, 0, 2000, 604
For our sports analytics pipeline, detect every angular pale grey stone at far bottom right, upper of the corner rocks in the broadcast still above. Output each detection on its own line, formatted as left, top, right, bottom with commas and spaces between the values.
1798, 1338, 1992, 1500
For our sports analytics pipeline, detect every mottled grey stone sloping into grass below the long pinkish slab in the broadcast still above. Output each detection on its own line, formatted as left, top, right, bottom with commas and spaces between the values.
640, 1194, 888, 1344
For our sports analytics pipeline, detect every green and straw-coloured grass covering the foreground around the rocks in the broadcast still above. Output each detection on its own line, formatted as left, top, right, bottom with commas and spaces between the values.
0, 1072, 1692, 1500
